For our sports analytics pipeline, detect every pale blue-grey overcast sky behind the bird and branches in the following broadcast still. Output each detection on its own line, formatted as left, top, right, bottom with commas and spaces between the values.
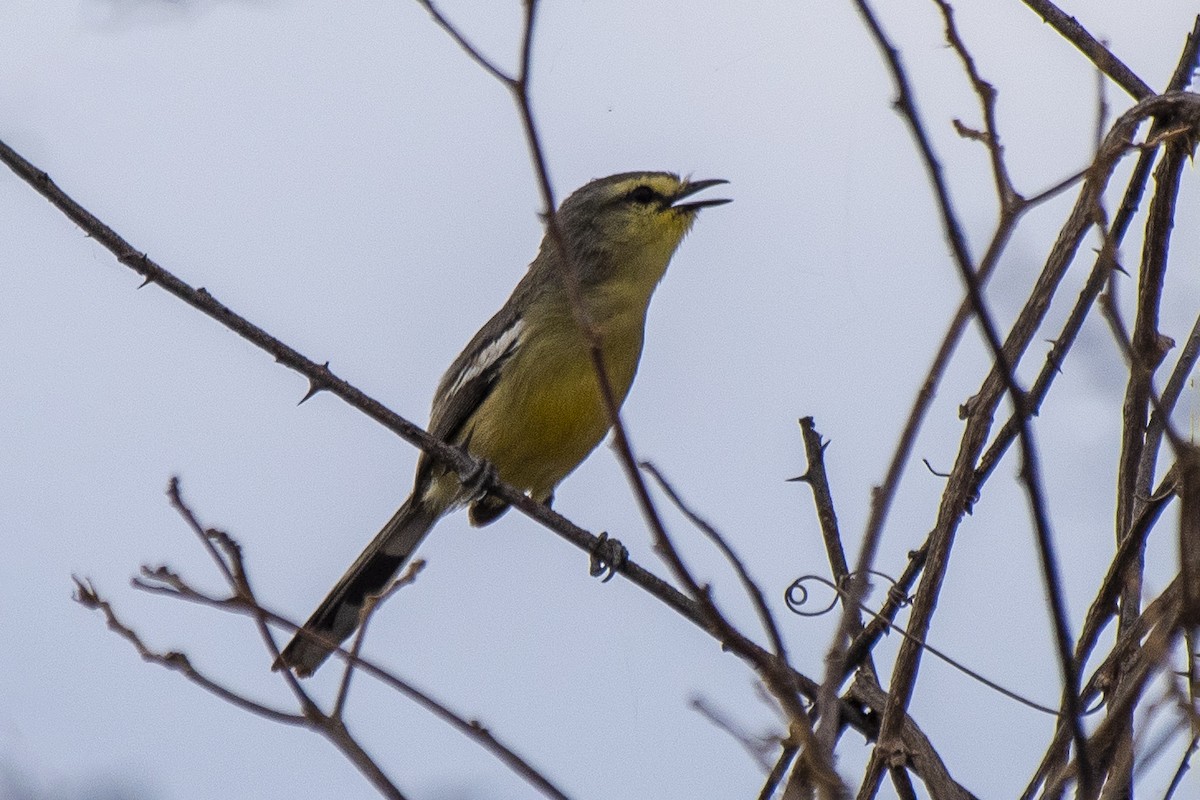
0, 0, 1200, 800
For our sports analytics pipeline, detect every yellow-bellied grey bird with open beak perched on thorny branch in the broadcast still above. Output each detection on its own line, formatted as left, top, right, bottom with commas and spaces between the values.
274, 172, 730, 678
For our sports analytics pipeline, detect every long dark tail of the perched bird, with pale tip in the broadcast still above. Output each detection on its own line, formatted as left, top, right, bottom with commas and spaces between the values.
272, 498, 440, 678
